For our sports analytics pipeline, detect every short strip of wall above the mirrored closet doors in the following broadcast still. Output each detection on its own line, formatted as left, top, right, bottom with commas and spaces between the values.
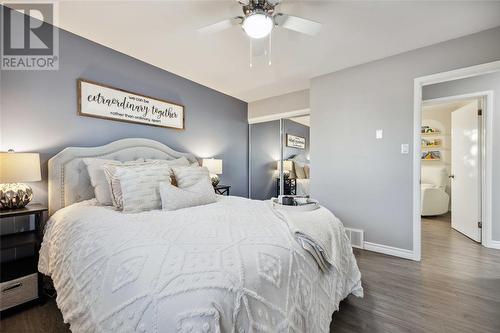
248, 90, 309, 119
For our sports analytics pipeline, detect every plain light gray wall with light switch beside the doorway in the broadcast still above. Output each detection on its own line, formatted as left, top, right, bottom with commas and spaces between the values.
310, 27, 500, 250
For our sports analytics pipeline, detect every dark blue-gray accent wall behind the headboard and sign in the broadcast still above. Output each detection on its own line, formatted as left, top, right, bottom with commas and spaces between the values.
0, 21, 248, 203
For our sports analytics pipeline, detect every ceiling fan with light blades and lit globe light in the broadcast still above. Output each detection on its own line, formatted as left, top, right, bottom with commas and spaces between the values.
198, 0, 321, 39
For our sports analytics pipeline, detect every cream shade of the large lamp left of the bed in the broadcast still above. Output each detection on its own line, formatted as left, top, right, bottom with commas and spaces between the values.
0, 152, 42, 183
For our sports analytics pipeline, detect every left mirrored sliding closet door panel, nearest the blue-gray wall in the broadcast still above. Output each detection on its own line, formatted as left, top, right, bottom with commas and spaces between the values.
250, 120, 280, 200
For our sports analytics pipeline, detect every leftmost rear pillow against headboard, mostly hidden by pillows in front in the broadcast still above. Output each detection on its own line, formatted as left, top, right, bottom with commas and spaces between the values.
83, 157, 144, 206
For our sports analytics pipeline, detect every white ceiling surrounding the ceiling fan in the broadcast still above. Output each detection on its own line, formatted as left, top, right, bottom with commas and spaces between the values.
44, 0, 500, 101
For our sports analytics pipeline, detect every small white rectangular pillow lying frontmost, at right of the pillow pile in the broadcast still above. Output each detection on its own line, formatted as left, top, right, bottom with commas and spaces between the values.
160, 177, 217, 210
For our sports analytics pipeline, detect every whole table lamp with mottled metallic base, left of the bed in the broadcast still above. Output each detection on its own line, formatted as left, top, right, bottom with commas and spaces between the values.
0, 150, 42, 209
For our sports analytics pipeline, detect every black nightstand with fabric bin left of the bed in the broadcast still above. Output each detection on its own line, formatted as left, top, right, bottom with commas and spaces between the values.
0, 204, 47, 313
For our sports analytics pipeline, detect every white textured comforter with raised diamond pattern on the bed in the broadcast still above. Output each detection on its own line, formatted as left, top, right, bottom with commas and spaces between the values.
39, 197, 363, 333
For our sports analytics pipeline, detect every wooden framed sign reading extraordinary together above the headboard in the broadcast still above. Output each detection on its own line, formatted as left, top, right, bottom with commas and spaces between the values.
77, 79, 184, 129
